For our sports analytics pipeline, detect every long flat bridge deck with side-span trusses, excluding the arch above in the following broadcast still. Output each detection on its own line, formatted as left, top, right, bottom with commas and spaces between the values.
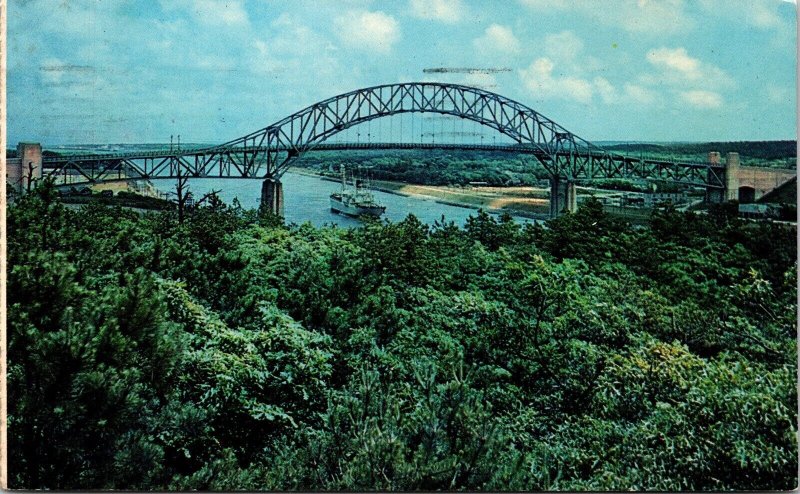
37, 142, 724, 191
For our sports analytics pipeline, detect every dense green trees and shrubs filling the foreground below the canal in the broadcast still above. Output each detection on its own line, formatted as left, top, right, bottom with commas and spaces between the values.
8, 188, 797, 490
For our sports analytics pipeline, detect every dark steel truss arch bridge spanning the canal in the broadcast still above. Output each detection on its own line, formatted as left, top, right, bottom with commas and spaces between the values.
37, 82, 726, 215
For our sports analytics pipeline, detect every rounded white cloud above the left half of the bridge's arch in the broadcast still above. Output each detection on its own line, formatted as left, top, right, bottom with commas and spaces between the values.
333, 10, 400, 53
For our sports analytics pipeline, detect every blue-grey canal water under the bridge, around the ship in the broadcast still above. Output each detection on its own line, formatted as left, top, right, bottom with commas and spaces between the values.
181, 172, 533, 226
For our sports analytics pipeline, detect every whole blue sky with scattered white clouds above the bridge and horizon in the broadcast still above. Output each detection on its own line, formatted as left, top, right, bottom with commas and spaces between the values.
7, 0, 797, 146
